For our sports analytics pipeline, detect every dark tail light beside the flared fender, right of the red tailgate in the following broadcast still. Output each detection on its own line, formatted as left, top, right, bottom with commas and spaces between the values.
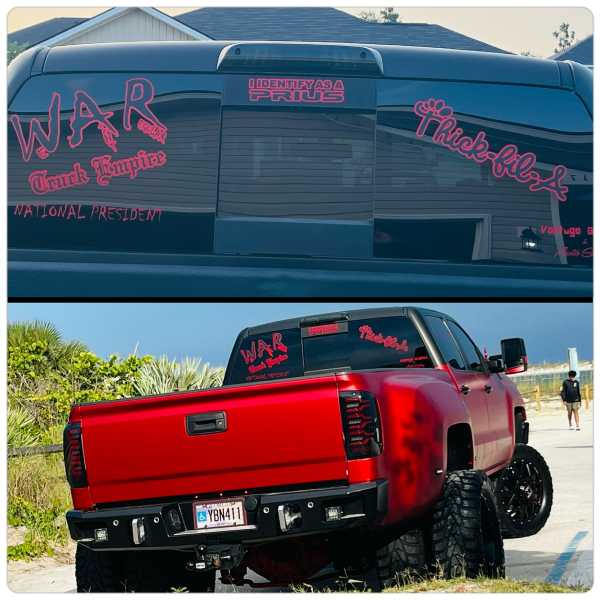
340, 391, 383, 459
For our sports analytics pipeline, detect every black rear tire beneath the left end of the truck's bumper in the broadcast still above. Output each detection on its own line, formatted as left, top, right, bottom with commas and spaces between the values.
75, 544, 216, 593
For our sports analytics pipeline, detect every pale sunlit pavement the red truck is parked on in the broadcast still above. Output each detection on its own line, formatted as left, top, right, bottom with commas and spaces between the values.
8, 411, 593, 592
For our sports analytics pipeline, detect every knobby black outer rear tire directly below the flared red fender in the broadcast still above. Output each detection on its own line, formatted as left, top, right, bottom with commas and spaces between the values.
430, 470, 505, 579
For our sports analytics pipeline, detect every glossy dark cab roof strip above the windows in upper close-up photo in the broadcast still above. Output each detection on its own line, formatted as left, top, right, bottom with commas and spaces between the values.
24, 41, 566, 87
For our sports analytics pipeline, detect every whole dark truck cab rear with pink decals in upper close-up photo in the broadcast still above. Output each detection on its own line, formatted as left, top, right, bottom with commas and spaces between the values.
8, 42, 593, 297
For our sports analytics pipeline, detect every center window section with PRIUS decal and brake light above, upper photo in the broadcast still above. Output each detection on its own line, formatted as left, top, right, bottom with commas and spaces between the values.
215, 43, 379, 258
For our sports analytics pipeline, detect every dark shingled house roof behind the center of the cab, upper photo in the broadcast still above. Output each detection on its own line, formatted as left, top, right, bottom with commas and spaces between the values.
176, 7, 506, 53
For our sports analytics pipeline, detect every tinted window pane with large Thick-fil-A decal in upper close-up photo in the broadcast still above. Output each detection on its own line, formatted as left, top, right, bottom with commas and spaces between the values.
374, 81, 593, 267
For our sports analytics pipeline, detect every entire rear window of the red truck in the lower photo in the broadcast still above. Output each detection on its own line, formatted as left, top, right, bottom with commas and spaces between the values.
226, 317, 433, 384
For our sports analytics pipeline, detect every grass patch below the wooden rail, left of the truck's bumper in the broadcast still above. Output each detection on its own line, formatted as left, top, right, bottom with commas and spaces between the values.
8, 454, 71, 560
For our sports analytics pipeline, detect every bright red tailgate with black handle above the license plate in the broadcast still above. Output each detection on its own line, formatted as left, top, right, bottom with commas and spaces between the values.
71, 375, 347, 504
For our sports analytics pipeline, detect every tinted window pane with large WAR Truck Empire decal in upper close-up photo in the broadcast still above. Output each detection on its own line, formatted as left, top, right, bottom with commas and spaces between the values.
8, 73, 220, 252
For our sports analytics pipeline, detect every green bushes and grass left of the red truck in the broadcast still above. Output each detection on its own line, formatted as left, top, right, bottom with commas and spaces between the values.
7, 322, 224, 559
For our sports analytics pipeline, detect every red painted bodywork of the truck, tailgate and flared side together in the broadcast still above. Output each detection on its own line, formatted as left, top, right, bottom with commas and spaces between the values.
71, 366, 523, 525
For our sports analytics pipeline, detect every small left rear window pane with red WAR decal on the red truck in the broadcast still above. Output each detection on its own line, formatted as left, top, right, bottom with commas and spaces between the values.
225, 329, 304, 384
